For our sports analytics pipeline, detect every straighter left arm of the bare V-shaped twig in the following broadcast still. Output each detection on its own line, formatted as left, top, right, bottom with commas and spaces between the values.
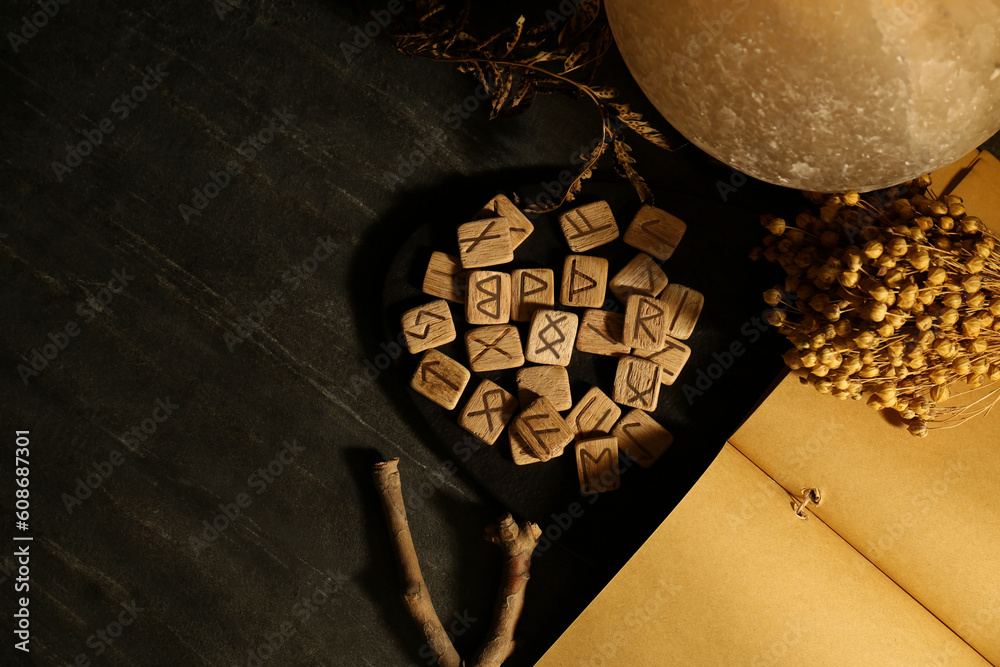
372, 458, 464, 667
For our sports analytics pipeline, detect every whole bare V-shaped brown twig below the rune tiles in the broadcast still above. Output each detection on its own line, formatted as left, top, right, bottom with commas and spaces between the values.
372, 458, 542, 667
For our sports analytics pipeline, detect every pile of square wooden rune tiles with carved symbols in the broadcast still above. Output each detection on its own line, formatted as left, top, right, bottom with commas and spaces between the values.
402, 195, 704, 493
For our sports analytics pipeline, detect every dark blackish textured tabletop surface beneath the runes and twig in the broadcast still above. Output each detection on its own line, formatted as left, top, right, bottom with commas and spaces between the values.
0, 0, 996, 666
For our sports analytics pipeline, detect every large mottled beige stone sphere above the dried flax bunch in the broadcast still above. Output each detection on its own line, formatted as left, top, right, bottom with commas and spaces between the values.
606, 0, 1000, 192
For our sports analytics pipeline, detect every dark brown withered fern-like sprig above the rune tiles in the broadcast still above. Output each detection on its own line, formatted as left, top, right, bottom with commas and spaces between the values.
389, 0, 679, 213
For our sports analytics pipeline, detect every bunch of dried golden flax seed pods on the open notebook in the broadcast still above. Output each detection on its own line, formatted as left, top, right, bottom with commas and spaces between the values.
751, 176, 1000, 436
